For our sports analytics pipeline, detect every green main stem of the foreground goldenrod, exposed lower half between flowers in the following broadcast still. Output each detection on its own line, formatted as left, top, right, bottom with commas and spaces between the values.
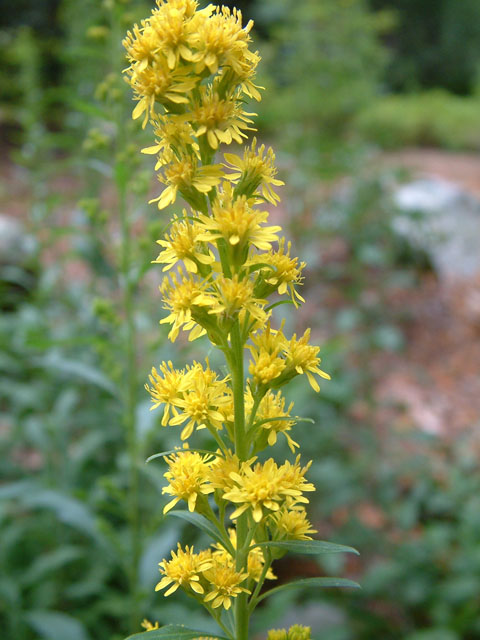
230, 320, 249, 640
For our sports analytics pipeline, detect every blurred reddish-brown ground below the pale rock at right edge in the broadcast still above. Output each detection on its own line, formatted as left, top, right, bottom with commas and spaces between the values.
374, 273, 480, 438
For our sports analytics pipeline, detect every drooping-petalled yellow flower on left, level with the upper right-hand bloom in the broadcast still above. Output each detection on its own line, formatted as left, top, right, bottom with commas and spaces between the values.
149, 155, 222, 209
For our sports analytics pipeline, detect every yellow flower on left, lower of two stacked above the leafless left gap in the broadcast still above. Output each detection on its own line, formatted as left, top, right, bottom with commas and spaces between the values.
160, 270, 212, 342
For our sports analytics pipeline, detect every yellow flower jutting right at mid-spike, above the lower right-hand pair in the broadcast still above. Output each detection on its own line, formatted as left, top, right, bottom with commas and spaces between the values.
253, 238, 305, 307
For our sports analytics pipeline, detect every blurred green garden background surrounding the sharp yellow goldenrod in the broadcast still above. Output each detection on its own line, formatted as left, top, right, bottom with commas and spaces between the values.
0, 0, 480, 640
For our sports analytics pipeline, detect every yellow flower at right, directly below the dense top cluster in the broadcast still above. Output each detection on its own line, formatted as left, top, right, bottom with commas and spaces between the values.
191, 86, 256, 149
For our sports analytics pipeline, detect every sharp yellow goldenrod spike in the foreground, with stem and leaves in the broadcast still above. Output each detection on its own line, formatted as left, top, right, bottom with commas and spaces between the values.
124, 0, 357, 640
